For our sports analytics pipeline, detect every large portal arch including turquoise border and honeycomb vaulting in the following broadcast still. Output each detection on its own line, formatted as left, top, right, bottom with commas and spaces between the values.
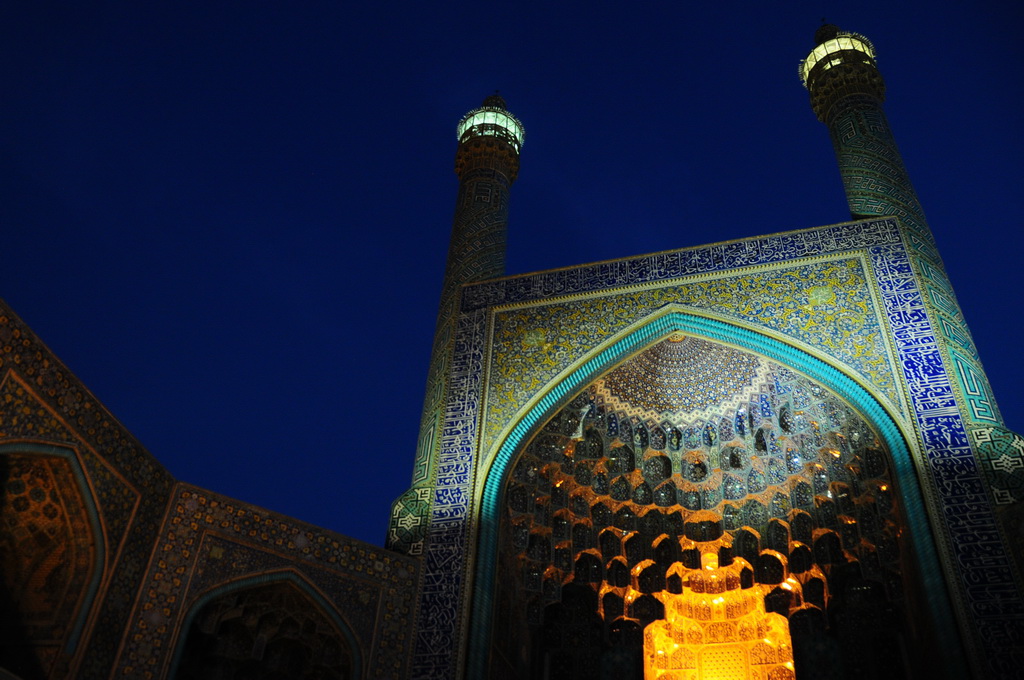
469, 310, 955, 677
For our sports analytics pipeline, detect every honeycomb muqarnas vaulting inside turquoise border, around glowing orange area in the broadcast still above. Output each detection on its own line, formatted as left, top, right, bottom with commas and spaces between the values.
490, 334, 913, 680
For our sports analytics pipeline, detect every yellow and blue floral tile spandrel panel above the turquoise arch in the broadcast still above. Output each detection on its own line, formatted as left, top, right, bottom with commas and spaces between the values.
481, 249, 905, 450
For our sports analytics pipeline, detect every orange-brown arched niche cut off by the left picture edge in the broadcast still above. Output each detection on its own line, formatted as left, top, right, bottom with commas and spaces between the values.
0, 442, 104, 678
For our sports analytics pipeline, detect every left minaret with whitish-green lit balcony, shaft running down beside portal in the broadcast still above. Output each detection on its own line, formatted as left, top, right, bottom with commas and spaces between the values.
387, 94, 525, 554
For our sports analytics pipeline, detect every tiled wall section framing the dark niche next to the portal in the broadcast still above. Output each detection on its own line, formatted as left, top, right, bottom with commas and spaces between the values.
118, 483, 419, 679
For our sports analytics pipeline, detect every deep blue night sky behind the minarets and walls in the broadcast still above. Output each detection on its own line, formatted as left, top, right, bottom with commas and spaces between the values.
0, 0, 1024, 544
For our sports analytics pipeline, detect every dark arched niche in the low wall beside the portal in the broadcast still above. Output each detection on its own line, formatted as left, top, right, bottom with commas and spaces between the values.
174, 571, 362, 680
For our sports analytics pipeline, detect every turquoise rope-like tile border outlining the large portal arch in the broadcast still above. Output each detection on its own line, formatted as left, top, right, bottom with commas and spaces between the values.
467, 310, 959, 678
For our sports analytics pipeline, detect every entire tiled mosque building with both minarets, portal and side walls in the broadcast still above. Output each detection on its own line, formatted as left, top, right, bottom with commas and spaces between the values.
0, 21, 1024, 680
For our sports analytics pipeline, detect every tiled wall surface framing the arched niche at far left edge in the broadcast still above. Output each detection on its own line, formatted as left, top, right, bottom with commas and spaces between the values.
0, 303, 171, 677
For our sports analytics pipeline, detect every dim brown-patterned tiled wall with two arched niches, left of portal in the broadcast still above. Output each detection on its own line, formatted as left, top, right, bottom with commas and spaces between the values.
0, 303, 420, 678
